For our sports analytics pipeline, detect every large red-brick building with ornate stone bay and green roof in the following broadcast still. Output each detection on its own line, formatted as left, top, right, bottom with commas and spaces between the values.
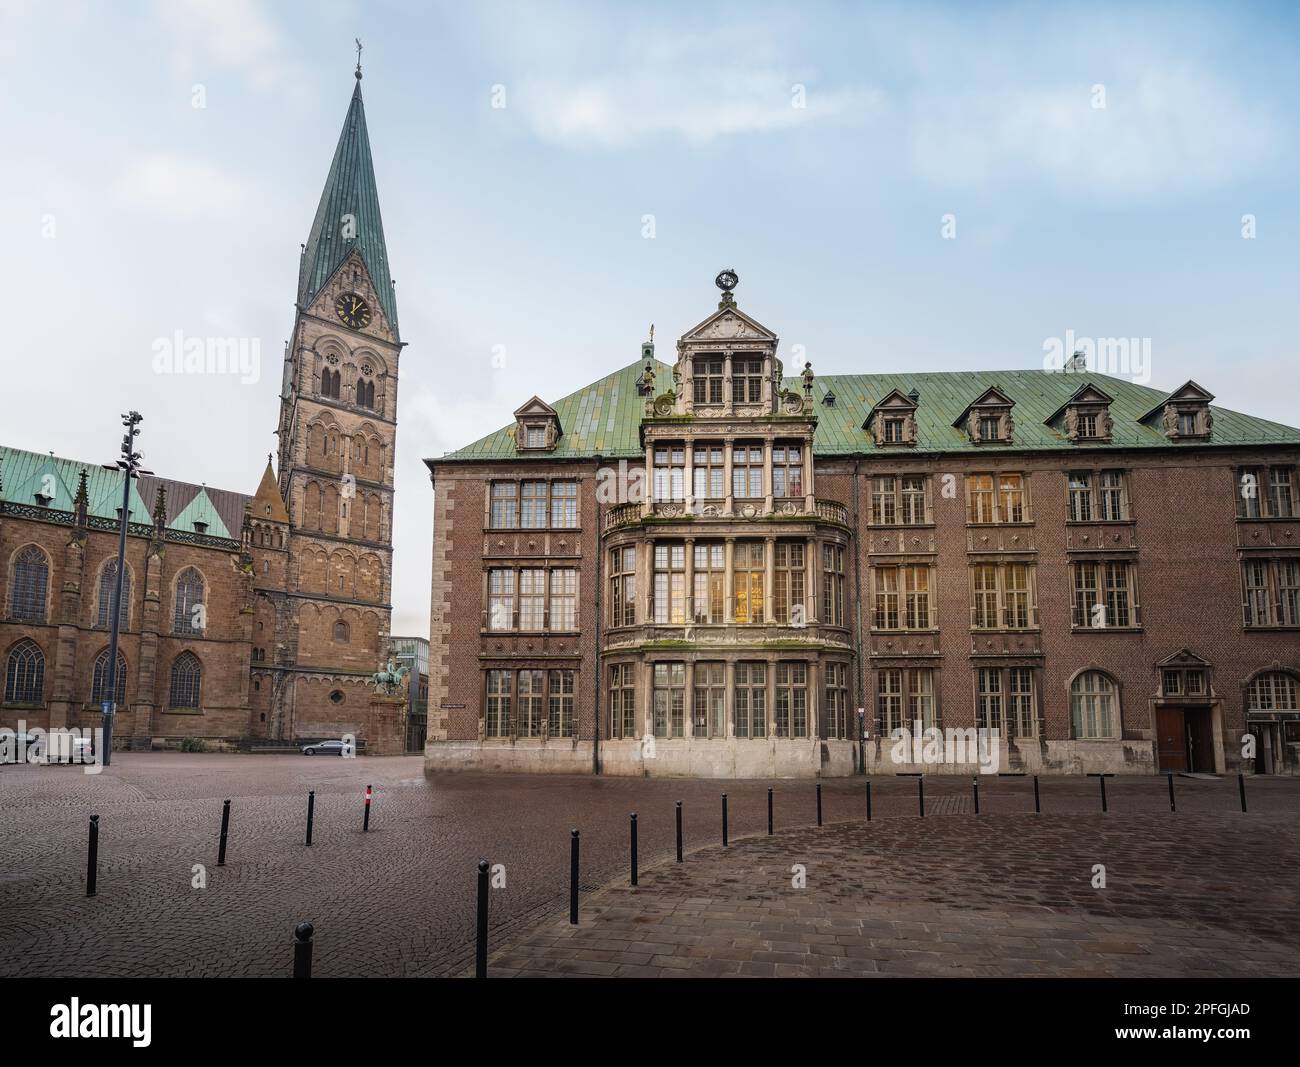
426, 272, 1300, 777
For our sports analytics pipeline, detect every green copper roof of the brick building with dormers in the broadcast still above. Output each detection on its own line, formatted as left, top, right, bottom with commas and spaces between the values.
433, 360, 1300, 463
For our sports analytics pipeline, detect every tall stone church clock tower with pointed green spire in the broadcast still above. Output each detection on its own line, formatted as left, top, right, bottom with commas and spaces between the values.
261, 62, 402, 739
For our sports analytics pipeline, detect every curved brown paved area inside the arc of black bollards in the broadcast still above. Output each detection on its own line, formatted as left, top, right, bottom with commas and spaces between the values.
489, 814, 1300, 977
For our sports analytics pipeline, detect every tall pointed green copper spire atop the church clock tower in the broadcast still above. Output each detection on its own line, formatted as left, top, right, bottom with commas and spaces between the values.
298, 75, 398, 334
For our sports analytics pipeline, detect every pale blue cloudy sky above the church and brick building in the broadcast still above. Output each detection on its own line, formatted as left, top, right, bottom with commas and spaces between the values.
0, 0, 1300, 636
